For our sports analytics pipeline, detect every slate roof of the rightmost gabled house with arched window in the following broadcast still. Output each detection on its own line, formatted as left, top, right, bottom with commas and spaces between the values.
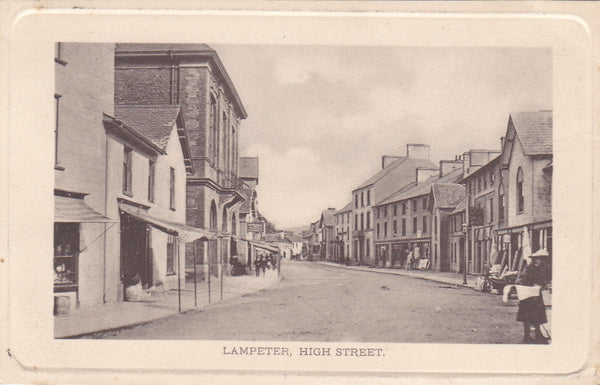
510, 111, 552, 155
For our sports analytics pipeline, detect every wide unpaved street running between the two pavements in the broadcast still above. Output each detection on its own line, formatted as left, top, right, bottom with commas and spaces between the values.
89, 261, 522, 344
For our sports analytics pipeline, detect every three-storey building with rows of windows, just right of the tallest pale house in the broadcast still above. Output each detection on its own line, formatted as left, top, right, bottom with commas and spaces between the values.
374, 160, 462, 267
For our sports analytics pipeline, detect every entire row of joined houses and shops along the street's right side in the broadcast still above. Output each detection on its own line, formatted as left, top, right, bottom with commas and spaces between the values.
305, 111, 552, 274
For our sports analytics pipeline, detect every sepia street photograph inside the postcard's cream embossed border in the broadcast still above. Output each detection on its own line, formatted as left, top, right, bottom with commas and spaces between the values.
54, 42, 553, 344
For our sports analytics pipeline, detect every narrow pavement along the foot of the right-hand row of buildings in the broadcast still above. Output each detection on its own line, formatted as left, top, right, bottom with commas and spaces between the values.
316, 261, 552, 307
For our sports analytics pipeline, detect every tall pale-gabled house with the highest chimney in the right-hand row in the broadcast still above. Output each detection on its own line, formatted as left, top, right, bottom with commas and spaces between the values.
351, 144, 436, 264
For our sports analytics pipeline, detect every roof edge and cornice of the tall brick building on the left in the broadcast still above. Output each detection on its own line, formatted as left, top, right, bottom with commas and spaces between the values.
115, 43, 248, 119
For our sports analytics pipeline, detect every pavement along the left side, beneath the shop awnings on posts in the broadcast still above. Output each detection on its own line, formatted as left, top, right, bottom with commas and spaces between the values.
54, 270, 279, 338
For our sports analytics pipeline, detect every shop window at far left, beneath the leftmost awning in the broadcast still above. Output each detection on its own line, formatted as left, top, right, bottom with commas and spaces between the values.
54, 223, 79, 291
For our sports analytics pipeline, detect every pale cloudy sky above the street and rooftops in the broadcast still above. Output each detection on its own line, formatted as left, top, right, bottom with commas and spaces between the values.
211, 44, 552, 228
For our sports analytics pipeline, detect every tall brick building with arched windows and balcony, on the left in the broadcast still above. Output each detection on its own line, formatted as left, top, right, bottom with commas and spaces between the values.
114, 44, 247, 275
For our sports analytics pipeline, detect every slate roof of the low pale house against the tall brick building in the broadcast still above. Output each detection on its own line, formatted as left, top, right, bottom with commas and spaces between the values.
115, 105, 179, 151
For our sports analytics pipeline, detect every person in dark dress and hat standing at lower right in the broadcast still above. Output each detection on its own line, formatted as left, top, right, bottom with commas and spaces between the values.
516, 249, 550, 344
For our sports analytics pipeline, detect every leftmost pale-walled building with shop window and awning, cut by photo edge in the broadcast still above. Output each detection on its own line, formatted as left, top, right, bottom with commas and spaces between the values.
54, 43, 117, 309
